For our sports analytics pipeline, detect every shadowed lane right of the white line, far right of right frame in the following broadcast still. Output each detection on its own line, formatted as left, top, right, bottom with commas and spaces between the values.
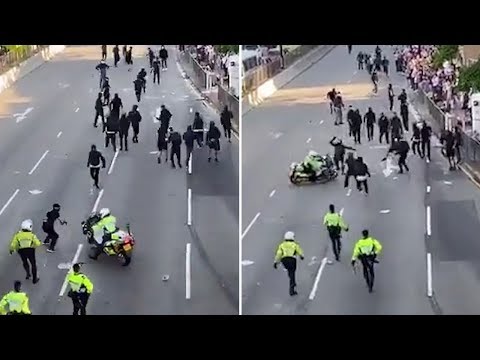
428, 139, 480, 315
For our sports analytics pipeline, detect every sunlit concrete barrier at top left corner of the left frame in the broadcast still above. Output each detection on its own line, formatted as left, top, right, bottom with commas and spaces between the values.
0, 45, 66, 93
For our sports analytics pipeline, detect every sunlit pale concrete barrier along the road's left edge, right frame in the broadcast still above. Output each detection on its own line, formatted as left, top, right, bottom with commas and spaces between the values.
242, 45, 337, 115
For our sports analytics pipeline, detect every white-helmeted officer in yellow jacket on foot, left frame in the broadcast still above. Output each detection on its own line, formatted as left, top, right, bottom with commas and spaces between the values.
10, 219, 42, 284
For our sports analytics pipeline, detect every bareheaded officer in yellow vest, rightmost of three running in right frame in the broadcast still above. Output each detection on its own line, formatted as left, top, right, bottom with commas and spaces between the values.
352, 230, 382, 292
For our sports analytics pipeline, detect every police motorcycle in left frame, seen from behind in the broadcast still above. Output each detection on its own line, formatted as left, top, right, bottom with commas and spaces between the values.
82, 209, 135, 266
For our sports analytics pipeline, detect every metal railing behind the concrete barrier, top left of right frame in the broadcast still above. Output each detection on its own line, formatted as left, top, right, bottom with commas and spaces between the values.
242, 45, 321, 95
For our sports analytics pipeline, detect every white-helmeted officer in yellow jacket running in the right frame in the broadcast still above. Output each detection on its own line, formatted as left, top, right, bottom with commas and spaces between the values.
273, 231, 304, 296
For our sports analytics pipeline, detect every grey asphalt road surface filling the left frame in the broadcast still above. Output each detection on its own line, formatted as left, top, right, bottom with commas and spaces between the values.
0, 45, 239, 314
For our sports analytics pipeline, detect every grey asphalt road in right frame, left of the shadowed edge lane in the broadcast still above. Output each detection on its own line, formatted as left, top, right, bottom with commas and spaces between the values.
242, 46, 436, 315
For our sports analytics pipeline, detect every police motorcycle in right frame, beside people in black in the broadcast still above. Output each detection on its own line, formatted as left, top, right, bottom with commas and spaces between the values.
288, 152, 338, 185
